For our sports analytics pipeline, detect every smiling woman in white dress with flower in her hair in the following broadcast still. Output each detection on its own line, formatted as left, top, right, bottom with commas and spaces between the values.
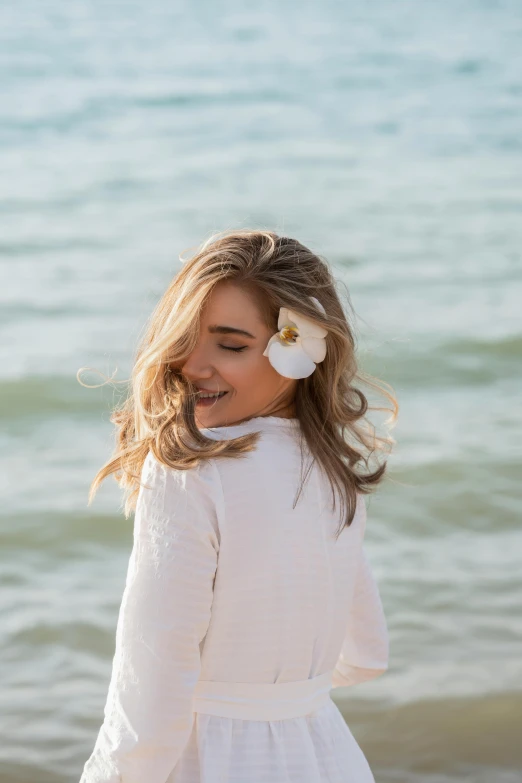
80, 230, 397, 783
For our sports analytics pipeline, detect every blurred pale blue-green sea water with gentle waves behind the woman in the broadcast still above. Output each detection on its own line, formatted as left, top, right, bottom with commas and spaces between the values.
0, 0, 522, 783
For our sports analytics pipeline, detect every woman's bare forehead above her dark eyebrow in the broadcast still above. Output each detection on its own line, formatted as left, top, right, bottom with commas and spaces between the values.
201, 282, 263, 328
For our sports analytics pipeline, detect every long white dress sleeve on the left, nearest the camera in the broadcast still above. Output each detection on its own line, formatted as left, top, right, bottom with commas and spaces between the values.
80, 452, 221, 783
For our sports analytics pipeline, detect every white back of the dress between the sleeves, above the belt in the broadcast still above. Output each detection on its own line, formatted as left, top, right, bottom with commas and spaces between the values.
201, 417, 365, 683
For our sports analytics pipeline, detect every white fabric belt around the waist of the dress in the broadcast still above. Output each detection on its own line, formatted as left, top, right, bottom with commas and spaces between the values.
193, 671, 333, 720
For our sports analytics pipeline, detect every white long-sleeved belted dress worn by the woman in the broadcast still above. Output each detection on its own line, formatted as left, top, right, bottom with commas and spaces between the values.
80, 416, 388, 783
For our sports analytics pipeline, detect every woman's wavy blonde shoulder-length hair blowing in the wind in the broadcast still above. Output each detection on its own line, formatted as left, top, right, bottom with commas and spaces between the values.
77, 229, 398, 535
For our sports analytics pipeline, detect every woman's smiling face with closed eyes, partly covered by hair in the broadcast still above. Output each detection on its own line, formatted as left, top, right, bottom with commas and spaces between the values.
180, 281, 297, 429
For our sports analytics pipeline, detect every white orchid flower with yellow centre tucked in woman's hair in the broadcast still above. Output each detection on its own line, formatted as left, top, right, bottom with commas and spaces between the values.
263, 296, 328, 378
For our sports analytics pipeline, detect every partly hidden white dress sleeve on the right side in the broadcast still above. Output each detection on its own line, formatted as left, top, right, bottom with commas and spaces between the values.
332, 502, 389, 688
